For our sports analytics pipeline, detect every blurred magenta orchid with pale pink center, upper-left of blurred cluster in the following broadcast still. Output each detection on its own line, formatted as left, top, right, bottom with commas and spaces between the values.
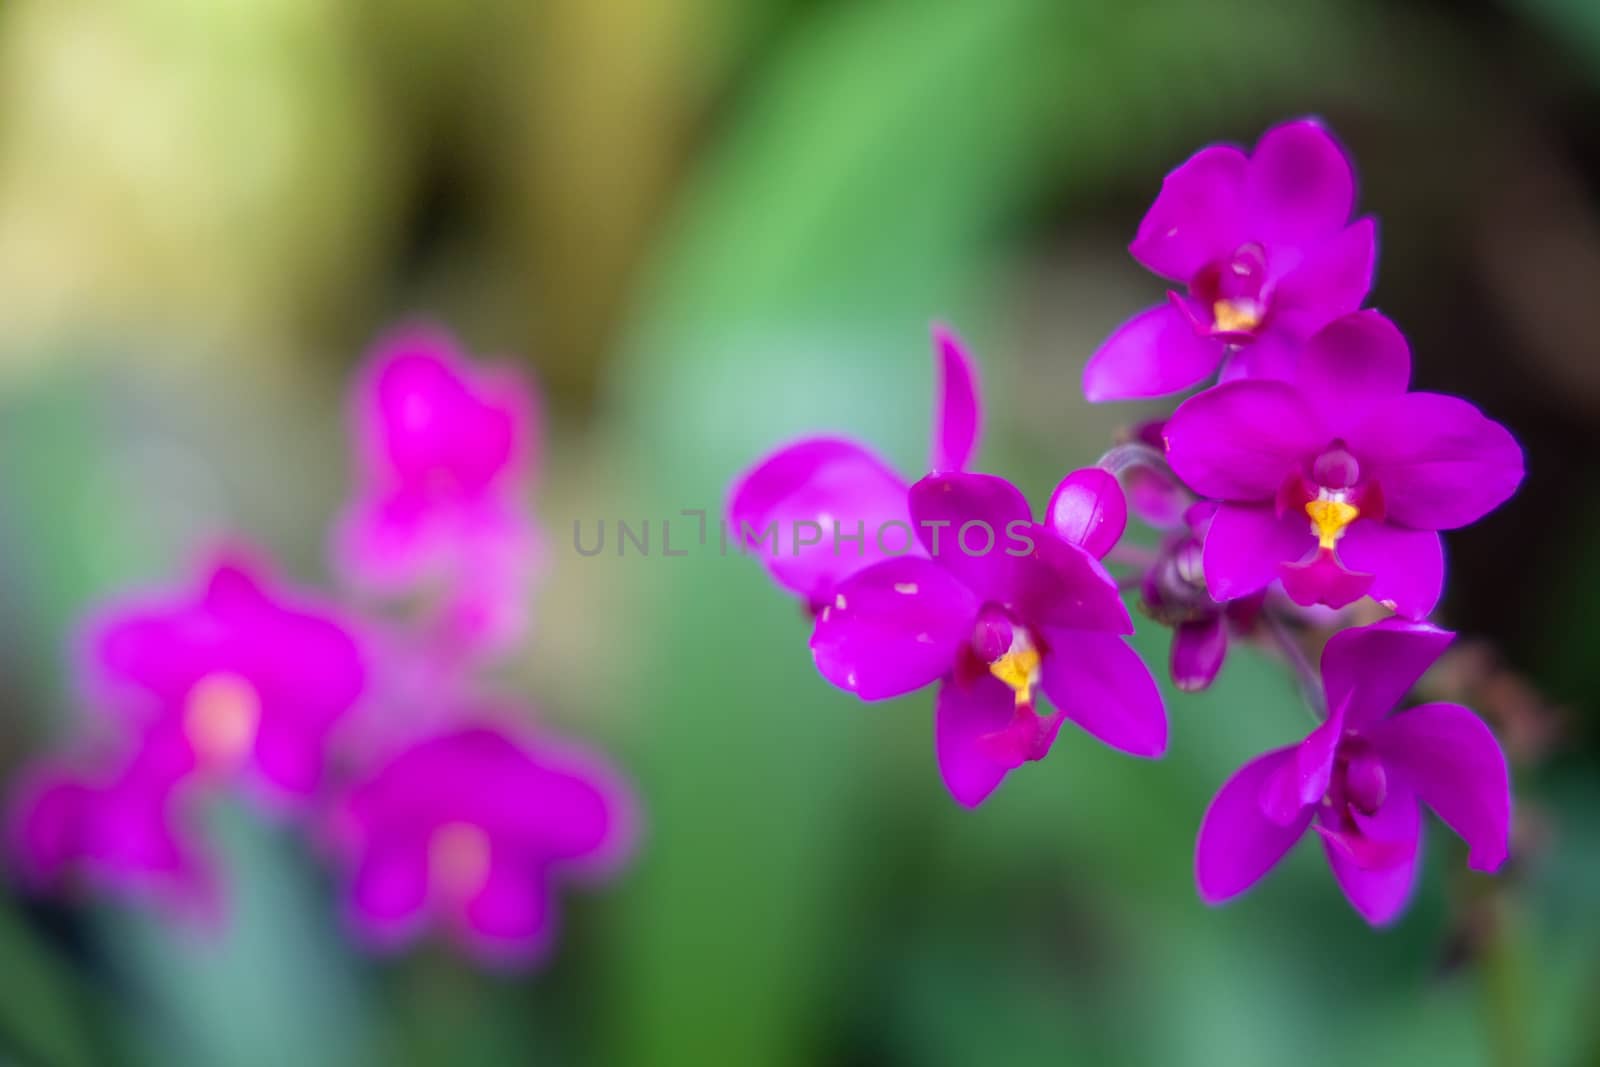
86, 561, 365, 801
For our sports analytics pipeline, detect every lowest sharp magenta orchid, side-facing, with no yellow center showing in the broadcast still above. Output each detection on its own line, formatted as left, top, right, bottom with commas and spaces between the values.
1195, 619, 1510, 926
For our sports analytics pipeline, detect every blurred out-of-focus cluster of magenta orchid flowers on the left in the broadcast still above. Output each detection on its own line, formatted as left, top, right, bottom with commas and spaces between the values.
10, 326, 635, 966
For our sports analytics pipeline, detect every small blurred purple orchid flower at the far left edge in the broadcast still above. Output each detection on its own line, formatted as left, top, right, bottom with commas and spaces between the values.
8, 735, 218, 918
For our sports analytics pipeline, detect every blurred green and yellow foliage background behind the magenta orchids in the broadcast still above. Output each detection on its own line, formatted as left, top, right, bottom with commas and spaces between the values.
0, 0, 1600, 1067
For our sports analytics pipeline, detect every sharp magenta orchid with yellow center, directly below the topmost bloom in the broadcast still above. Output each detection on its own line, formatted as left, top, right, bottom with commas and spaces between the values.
1165, 312, 1523, 619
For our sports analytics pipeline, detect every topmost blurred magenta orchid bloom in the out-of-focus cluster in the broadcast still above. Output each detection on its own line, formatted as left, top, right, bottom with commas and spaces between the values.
334, 326, 539, 646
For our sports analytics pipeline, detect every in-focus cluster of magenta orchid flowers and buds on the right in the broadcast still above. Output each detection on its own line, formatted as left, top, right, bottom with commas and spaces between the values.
728, 120, 1523, 925
